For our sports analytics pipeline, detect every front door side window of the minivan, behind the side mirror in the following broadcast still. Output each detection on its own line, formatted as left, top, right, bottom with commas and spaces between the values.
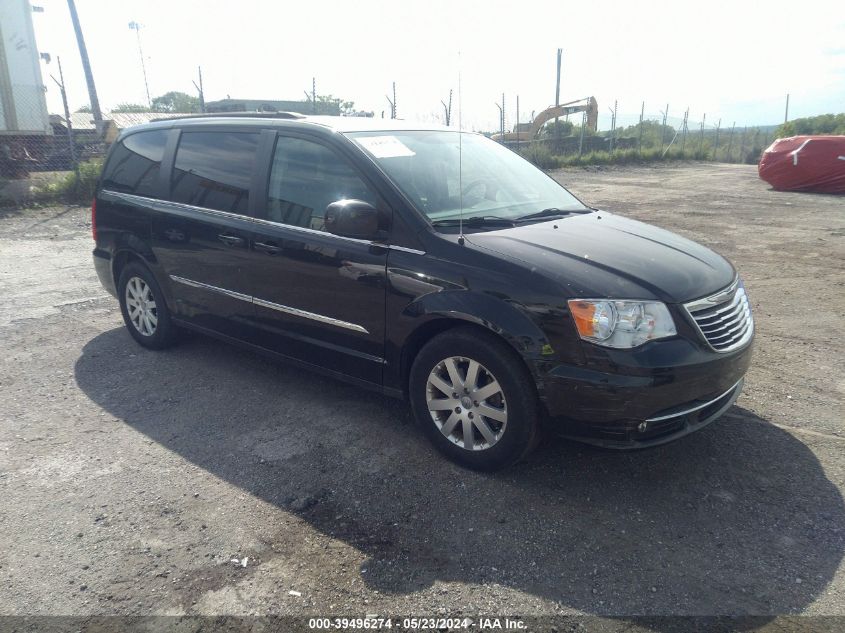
267, 137, 376, 230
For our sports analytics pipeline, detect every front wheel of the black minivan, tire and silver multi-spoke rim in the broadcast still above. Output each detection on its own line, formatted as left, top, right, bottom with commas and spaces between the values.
408, 327, 539, 471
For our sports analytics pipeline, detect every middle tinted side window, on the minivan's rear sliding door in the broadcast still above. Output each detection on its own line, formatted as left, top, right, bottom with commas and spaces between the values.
170, 132, 258, 215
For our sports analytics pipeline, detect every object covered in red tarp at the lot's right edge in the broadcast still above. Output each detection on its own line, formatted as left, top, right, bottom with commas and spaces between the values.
758, 136, 845, 193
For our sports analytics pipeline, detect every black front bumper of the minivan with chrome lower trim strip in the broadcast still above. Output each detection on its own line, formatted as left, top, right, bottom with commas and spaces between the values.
540, 341, 752, 449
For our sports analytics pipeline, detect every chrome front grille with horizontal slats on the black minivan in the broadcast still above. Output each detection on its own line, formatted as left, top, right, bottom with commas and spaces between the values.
685, 280, 754, 352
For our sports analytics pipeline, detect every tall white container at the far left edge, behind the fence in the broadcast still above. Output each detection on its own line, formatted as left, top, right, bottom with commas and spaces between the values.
0, 0, 52, 134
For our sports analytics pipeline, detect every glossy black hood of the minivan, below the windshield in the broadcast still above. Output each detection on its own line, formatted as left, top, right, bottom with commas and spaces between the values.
465, 211, 736, 303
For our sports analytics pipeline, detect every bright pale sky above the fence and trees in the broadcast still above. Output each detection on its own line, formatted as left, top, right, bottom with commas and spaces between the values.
26, 0, 845, 130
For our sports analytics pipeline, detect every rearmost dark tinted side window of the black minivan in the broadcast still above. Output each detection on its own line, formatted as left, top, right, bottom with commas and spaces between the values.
103, 130, 167, 197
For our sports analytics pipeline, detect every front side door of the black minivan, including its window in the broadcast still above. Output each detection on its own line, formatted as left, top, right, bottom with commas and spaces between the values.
248, 135, 388, 384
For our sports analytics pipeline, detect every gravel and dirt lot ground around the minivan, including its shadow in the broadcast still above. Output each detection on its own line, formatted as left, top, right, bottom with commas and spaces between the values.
0, 164, 845, 617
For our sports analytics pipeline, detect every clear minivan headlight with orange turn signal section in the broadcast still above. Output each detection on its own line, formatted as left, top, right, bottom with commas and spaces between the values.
569, 299, 678, 348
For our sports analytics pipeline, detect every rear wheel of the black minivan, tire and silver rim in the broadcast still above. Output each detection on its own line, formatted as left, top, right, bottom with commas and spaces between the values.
117, 262, 178, 349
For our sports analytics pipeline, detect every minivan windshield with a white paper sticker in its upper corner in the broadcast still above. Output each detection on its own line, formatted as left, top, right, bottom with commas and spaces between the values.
348, 130, 589, 225
